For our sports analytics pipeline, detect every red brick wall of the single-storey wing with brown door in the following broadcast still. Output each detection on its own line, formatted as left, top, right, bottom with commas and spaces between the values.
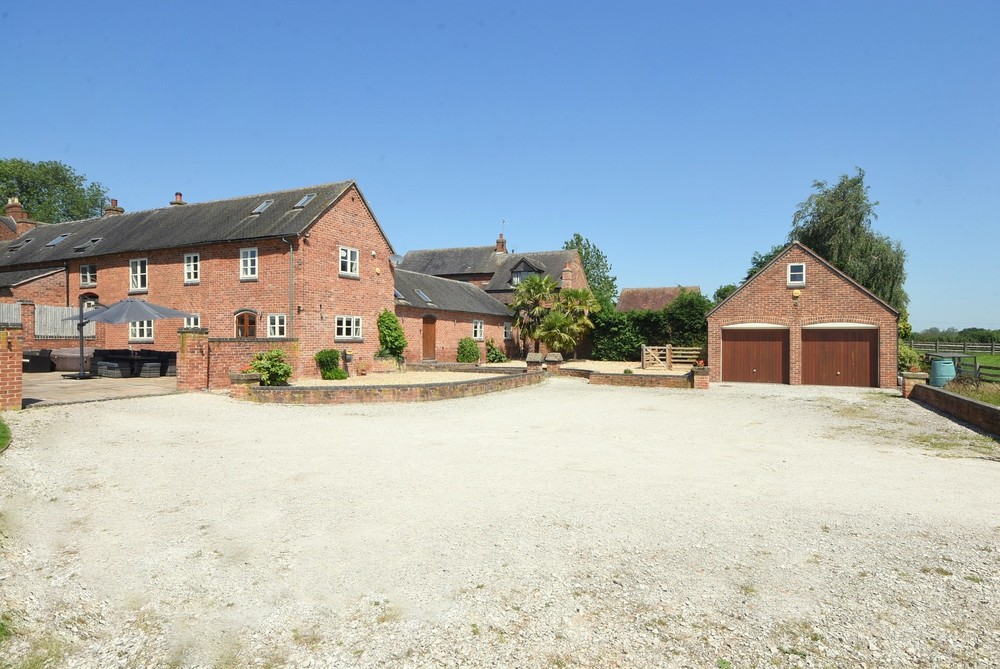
394, 306, 514, 362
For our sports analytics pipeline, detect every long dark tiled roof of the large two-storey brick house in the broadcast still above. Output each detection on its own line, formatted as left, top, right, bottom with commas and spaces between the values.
0, 181, 388, 267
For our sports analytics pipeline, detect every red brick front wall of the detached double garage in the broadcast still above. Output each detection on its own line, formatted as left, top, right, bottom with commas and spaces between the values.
708, 245, 898, 388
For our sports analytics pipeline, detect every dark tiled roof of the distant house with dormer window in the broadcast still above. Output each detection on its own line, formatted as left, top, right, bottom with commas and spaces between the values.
399, 246, 577, 291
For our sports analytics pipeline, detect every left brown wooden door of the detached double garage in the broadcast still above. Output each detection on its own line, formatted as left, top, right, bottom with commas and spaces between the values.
722, 328, 788, 383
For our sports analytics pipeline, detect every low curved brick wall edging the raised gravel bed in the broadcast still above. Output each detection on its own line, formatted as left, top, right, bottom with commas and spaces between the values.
247, 365, 545, 404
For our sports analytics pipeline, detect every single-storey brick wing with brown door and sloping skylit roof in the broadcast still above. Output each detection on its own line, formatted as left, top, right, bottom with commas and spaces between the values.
395, 267, 513, 362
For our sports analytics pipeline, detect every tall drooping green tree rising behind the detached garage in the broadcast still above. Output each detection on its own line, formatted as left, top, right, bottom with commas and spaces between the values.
788, 167, 909, 311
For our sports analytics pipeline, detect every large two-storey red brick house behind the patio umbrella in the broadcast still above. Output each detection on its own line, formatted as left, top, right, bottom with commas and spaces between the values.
0, 181, 395, 377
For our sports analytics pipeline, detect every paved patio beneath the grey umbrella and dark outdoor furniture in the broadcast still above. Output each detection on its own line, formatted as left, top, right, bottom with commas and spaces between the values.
21, 372, 177, 409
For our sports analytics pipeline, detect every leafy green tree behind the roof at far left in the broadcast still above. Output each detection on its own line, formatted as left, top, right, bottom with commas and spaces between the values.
0, 158, 108, 223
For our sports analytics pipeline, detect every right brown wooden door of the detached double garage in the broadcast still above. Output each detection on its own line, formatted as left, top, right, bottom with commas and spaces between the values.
802, 329, 878, 388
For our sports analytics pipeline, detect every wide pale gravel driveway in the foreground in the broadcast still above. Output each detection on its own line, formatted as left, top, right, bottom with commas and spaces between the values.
0, 378, 1000, 668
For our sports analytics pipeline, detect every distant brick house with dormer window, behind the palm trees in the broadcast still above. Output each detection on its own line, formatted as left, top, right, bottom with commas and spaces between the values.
399, 233, 590, 304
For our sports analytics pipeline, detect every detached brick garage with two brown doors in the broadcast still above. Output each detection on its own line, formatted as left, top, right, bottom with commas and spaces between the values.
708, 242, 899, 388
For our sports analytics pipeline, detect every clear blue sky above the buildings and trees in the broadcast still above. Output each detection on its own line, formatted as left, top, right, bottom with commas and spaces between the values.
0, 0, 1000, 329
